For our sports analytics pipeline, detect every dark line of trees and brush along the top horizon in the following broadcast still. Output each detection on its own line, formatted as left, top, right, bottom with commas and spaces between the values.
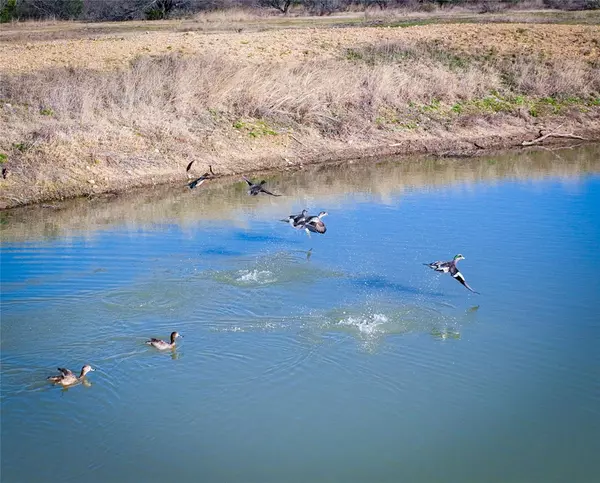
0, 0, 600, 22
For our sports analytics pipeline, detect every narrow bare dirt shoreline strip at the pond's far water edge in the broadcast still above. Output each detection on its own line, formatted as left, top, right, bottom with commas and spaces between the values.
0, 121, 600, 211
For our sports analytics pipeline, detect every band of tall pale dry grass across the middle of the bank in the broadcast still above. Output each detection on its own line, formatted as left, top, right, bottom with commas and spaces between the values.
0, 42, 600, 144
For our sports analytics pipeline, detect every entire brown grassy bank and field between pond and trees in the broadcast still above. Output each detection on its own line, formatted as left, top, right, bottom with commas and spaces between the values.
0, 8, 600, 207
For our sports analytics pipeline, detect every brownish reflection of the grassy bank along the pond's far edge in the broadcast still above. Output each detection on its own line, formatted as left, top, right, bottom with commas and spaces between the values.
0, 144, 600, 242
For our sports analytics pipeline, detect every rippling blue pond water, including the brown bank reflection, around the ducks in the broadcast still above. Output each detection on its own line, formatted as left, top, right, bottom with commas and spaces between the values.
0, 146, 600, 483
